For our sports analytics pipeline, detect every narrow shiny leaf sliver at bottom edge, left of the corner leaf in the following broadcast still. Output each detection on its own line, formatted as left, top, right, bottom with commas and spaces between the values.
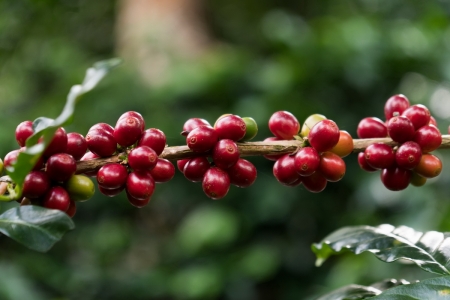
317, 279, 409, 300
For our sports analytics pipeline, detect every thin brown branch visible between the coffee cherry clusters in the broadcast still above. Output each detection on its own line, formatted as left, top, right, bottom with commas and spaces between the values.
77, 135, 450, 174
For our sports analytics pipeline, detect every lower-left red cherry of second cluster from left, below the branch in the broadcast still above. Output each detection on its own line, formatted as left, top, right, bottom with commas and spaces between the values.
97, 163, 128, 190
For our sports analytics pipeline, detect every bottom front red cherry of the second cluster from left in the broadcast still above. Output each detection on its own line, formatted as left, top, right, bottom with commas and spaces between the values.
126, 171, 155, 200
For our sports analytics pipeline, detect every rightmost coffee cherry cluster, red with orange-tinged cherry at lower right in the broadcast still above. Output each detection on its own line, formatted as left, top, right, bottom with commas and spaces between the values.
357, 95, 442, 191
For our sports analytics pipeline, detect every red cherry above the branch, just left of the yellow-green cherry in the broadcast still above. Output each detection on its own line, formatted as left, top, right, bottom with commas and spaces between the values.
269, 111, 300, 140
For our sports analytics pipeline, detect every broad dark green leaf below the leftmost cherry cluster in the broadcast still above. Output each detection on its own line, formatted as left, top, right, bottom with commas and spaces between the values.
0, 205, 75, 252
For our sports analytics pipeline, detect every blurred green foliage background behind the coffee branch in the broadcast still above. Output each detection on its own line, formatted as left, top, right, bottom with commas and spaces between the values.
0, 0, 450, 300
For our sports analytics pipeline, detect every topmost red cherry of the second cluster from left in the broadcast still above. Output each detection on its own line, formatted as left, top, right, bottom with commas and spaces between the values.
114, 116, 143, 147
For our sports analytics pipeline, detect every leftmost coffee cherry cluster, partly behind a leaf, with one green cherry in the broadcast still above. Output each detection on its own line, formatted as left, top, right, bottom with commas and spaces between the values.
4, 121, 95, 217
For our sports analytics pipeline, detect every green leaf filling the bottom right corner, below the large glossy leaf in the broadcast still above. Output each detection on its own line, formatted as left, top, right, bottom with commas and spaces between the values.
369, 276, 450, 300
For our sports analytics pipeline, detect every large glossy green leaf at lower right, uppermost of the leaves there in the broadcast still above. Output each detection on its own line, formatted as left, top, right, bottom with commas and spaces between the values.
312, 224, 450, 275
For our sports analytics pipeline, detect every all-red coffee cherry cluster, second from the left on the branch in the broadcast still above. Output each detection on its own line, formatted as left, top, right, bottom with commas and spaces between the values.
81, 111, 175, 207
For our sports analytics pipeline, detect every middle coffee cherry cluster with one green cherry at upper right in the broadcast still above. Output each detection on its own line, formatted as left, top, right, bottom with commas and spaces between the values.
177, 114, 258, 199
